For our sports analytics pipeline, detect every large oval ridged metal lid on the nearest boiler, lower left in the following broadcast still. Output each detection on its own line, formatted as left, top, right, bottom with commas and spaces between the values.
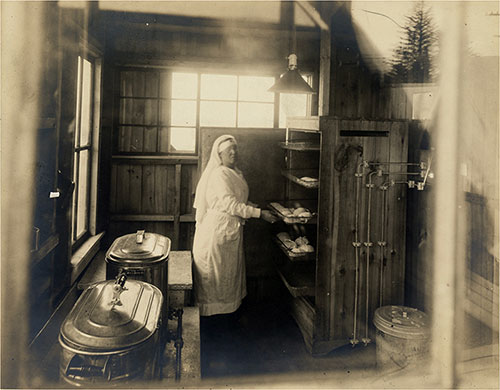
60, 280, 163, 351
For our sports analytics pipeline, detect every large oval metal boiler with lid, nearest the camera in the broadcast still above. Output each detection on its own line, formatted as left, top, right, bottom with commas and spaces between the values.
59, 275, 163, 386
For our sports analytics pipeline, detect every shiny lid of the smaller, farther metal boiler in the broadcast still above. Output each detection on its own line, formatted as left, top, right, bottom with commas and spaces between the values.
106, 230, 170, 264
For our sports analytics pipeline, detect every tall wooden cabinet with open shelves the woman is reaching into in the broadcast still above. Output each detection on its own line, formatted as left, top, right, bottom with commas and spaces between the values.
278, 116, 408, 355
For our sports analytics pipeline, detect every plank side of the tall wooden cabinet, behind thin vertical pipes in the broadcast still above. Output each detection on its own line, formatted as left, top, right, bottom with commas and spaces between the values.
315, 117, 410, 349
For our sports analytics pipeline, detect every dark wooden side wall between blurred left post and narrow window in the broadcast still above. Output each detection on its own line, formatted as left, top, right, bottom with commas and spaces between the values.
30, 3, 107, 341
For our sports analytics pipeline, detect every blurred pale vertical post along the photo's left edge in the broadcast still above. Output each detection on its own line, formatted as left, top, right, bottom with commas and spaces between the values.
1, 2, 46, 388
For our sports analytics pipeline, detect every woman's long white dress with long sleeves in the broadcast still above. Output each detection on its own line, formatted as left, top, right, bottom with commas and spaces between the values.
193, 136, 260, 316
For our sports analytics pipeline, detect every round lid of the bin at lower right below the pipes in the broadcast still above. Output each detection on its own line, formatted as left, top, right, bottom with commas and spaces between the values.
373, 306, 430, 339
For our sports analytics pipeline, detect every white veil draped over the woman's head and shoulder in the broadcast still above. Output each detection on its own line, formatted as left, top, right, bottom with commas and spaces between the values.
193, 135, 236, 222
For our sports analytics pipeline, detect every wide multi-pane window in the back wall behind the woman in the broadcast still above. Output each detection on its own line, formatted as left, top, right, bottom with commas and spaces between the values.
117, 69, 312, 154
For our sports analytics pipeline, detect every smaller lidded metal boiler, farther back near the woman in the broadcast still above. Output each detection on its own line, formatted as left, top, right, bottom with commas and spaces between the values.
106, 230, 170, 299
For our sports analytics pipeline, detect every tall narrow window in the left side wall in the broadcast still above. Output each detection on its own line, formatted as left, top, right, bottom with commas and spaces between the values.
71, 57, 100, 246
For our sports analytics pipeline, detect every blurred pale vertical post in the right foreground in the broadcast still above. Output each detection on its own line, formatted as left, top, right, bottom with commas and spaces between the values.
431, 4, 465, 388
